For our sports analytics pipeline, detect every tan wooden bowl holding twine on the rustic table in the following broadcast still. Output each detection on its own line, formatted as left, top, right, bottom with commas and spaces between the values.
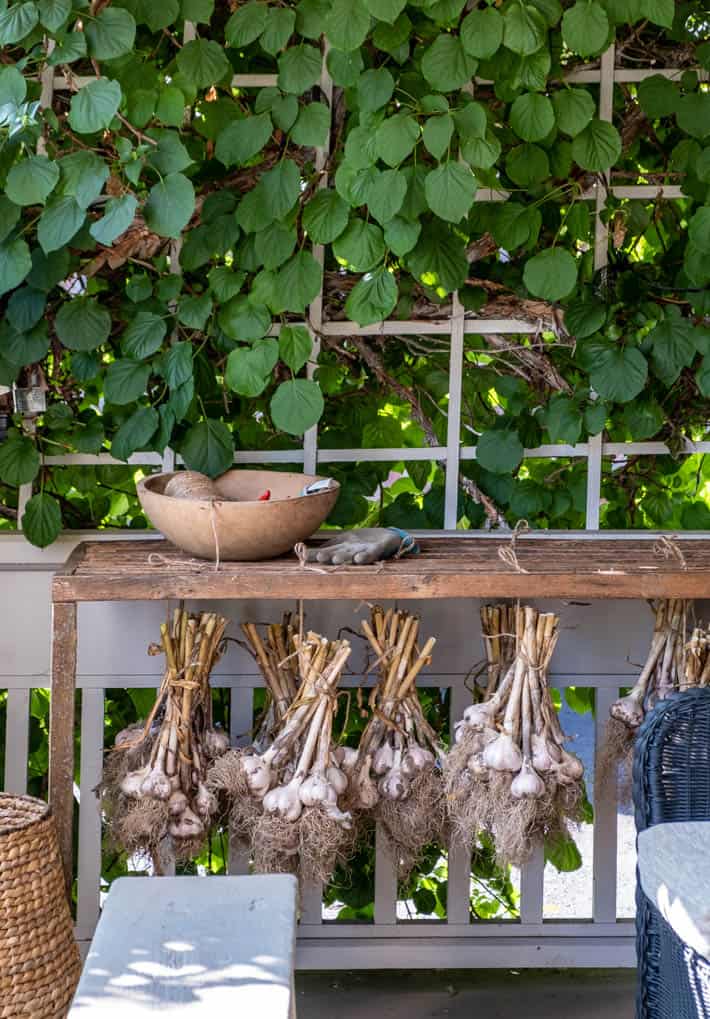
136, 471, 340, 562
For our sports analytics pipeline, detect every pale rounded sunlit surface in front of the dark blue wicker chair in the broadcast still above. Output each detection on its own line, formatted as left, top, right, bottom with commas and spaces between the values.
639, 821, 710, 958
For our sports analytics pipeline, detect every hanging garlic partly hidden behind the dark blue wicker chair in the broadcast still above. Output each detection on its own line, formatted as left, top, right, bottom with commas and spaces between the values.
601, 598, 696, 794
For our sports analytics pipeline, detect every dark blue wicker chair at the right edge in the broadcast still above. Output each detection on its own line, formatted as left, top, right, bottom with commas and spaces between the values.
634, 688, 710, 1019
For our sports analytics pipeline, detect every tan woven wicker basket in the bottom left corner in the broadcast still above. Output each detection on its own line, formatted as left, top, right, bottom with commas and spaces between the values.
0, 793, 81, 1019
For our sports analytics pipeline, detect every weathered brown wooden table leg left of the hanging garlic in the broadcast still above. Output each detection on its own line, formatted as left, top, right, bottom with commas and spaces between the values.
49, 601, 76, 894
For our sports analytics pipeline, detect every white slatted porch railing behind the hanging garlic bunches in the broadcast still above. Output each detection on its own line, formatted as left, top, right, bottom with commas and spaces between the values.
0, 534, 651, 969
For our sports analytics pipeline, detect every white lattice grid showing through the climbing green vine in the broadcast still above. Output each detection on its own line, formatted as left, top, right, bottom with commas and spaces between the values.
18, 37, 710, 531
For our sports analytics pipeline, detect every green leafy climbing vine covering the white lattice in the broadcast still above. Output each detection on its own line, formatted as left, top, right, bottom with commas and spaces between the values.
0, 0, 710, 545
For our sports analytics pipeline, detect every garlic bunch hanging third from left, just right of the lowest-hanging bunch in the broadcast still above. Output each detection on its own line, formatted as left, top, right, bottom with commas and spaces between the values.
350, 606, 443, 872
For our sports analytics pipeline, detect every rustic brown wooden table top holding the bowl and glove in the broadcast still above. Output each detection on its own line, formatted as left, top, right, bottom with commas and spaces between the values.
52, 533, 710, 602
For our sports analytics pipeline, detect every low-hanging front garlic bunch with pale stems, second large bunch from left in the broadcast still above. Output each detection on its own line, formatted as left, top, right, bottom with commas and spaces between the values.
211, 632, 351, 880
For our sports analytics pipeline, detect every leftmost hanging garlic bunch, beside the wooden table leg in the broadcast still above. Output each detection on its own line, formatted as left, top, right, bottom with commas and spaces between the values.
101, 607, 229, 870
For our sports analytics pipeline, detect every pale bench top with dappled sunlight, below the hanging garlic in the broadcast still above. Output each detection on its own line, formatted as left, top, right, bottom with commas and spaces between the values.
69, 874, 296, 1019
